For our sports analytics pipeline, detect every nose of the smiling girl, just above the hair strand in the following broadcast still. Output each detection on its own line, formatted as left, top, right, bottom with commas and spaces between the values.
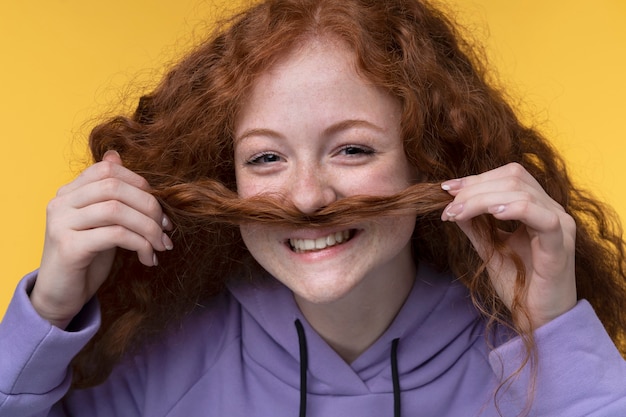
289, 169, 337, 214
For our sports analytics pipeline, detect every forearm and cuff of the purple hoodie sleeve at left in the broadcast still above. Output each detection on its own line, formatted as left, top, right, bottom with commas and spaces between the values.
0, 273, 100, 417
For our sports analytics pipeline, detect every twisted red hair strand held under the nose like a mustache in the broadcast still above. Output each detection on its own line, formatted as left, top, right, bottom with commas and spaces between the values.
153, 179, 452, 227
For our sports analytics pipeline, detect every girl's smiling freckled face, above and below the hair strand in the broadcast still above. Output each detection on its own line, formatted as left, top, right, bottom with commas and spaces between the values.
235, 40, 415, 303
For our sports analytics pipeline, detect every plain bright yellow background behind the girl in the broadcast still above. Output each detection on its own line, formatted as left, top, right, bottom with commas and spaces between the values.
0, 0, 626, 316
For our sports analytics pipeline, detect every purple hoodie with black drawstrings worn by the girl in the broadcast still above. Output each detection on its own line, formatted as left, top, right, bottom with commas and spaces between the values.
0, 265, 626, 417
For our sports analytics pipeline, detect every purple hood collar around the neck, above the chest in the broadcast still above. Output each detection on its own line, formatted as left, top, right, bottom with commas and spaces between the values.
229, 264, 484, 395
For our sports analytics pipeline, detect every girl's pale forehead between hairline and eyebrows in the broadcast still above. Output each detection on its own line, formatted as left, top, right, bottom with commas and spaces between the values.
235, 39, 399, 132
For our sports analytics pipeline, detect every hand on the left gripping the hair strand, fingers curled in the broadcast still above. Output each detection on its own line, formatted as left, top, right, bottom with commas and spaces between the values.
30, 151, 173, 328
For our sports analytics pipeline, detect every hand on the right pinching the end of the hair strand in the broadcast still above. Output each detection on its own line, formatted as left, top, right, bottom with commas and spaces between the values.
441, 163, 577, 329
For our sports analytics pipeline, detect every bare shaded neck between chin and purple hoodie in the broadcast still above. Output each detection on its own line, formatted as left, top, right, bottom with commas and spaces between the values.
295, 261, 416, 363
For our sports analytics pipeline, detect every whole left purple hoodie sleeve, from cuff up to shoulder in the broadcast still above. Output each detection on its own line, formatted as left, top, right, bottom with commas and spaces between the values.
0, 274, 240, 417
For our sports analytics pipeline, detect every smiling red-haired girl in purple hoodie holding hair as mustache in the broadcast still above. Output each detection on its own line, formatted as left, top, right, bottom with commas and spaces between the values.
0, 0, 626, 417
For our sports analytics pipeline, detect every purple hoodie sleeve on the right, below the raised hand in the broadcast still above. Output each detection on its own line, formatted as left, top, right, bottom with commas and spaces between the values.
489, 300, 626, 417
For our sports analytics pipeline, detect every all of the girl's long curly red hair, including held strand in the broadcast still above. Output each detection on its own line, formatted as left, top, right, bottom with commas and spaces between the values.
69, 0, 626, 410
